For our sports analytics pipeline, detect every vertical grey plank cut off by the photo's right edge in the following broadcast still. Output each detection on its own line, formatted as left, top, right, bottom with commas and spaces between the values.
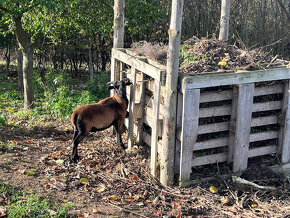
278, 81, 290, 164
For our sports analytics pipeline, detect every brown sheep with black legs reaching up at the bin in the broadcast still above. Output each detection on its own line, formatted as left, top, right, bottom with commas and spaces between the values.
70, 78, 132, 162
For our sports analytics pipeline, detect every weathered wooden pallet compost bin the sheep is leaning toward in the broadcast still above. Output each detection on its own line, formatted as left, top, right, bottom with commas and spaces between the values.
112, 49, 290, 186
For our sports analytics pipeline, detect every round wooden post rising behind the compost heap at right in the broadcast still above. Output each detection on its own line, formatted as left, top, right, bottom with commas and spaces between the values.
219, 0, 231, 41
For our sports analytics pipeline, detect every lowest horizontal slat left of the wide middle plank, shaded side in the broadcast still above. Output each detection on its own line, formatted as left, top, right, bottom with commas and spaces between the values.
191, 152, 228, 167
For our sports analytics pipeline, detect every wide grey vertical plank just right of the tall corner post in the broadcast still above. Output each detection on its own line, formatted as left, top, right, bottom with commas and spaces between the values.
180, 89, 200, 183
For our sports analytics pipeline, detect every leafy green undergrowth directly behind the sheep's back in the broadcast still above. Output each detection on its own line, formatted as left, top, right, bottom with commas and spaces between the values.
35, 69, 109, 119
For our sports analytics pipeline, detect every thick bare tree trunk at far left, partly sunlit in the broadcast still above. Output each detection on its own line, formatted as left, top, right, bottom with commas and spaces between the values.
13, 17, 34, 109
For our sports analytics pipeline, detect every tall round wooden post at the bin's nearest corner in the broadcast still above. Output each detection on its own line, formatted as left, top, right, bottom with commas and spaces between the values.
160, 0, 184, 185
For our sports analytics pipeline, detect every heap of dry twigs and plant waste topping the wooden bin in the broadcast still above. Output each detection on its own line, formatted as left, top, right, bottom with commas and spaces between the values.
131, 37, 290, 74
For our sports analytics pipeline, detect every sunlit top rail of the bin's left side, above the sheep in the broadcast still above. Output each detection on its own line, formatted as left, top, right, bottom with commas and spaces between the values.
112, 48, 164, 79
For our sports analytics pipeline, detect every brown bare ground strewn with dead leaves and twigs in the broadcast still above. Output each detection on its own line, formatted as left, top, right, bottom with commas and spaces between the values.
0, 121, 290, 217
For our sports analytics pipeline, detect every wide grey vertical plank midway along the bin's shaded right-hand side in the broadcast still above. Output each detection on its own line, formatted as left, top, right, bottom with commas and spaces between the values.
233, 83, 255, 173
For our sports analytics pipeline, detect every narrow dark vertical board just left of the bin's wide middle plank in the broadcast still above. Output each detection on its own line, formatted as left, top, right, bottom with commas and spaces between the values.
228, 86, 239, 163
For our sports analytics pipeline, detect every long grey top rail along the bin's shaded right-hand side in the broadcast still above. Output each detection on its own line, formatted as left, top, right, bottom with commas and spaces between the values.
180, 67, 290, 89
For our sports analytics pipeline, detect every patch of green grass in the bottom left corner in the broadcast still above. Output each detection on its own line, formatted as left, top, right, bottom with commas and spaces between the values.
0, 182, 72, 218
